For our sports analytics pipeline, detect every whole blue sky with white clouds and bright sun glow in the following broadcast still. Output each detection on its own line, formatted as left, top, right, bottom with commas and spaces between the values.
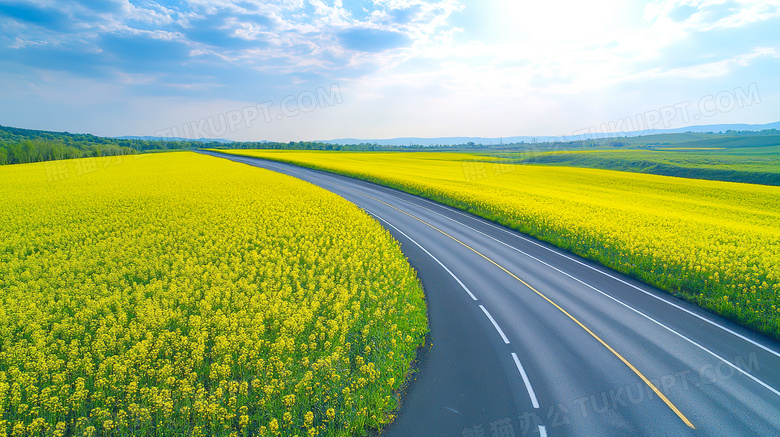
0, 0, 780, 141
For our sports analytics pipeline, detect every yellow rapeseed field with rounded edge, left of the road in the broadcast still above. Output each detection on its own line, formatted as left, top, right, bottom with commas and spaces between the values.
0, 153, 427, 437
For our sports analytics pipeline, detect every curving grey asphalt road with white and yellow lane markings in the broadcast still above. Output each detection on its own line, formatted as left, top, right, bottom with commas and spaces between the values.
203, 151, 780, 437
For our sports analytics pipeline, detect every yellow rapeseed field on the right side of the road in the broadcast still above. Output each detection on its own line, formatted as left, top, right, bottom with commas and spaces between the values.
221, 150, 780, 338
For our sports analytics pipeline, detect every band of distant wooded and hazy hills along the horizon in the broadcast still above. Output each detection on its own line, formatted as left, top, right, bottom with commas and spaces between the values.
0, 122, 780, 164
